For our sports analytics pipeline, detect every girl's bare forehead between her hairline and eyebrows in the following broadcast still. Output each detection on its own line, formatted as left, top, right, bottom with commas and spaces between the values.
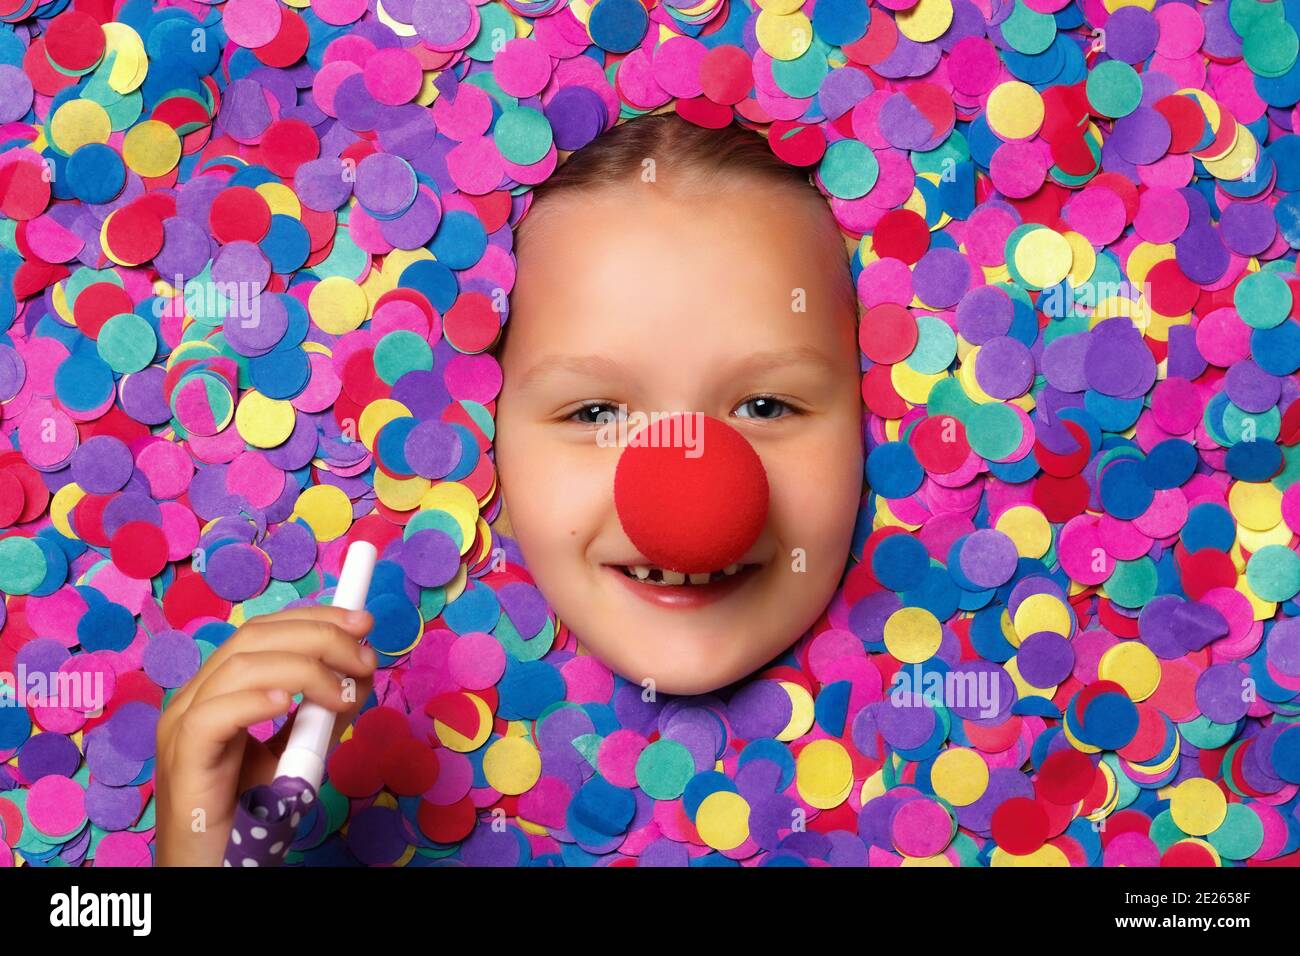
503, 183, 857, 369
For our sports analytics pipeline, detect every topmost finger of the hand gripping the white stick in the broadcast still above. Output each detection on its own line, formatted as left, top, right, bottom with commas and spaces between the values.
169, 616, 374, 710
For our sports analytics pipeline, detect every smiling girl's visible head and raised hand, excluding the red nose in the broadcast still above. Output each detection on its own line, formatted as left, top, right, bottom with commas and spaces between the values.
156, 112, 863, 865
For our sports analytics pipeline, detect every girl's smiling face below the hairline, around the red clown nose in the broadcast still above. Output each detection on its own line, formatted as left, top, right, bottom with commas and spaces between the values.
495, 183, 863, 695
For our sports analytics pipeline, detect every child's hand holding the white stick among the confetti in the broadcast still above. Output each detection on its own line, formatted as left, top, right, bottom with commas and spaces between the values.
153, 606, 376, 866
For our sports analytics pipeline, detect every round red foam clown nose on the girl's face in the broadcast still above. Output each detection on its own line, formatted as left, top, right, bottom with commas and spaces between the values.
614, 412, 767, 574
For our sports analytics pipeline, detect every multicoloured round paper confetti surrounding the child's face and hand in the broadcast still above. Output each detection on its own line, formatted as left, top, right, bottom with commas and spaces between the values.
0, 0, 1300, 866
